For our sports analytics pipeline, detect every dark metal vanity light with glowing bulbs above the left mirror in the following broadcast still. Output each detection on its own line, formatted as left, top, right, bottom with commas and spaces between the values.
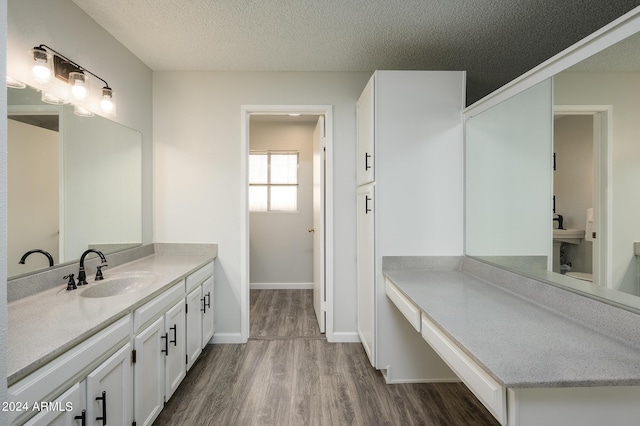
30, 44, 115, 117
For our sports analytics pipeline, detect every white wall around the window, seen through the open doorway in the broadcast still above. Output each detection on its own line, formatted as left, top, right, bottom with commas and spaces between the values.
249, 118, 316, 288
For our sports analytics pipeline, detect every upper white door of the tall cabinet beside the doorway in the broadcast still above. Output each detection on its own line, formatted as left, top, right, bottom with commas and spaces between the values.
356, 77, 375, 185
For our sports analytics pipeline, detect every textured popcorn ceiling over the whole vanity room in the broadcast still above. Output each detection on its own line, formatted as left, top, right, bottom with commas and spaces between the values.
73, 0, 640, 103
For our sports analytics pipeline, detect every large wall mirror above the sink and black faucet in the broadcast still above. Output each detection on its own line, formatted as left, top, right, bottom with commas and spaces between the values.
7, 81, 142, 279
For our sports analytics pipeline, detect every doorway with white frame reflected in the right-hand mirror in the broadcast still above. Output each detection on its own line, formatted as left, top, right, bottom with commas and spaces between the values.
553, 105, 612, 287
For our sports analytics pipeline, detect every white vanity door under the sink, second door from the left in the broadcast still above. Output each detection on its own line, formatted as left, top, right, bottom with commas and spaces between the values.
87, 343, 133, 426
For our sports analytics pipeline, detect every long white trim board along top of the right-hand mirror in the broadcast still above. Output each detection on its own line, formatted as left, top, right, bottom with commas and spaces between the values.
463, 7, 640, 120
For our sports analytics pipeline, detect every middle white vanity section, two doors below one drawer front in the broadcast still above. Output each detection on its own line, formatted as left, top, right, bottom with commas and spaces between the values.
133, 281, 186, 425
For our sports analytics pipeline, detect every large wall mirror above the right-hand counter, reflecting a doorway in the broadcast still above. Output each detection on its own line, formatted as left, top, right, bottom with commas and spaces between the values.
465, 19, 640, 310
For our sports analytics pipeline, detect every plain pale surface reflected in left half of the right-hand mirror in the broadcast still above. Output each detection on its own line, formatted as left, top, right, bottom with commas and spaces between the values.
465, 79, 553, 258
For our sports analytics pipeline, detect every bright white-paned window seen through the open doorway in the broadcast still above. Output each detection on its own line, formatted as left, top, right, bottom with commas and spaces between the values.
249, 151, 298, 212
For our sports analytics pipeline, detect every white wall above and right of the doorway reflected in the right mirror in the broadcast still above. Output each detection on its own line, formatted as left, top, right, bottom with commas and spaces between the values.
554, 72, 640, 295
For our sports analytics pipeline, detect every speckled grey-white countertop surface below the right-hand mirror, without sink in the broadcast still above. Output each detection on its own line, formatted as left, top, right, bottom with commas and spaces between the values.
385, 270, 640, 388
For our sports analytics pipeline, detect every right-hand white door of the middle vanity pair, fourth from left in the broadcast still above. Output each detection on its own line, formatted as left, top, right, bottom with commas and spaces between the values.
163, 300, 187, 401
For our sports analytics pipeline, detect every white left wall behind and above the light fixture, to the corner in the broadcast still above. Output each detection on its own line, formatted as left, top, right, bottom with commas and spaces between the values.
7, 0, 153, 243
